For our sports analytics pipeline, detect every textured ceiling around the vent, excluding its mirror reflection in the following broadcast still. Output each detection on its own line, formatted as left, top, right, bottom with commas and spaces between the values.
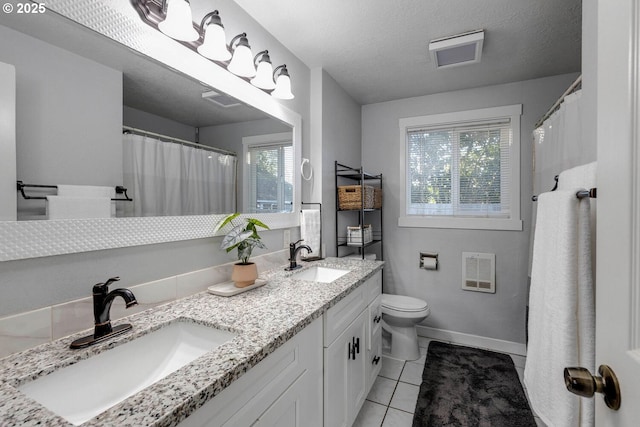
235, 0, 582, 104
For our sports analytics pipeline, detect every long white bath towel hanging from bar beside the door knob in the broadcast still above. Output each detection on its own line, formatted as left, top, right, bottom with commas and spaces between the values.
524, 190, 595, 427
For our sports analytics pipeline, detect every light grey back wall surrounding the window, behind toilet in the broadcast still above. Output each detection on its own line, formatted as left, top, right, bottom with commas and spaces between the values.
362, 74, 576, 343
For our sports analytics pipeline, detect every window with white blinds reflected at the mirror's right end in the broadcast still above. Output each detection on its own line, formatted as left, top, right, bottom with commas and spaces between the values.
248, 142, 293, 213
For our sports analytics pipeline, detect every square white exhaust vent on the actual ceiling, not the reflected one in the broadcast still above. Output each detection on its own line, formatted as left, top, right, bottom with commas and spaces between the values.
429, 30, 484, 68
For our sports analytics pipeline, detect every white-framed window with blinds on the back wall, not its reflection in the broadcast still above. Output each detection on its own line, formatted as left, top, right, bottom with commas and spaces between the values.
399, 105, 522, 230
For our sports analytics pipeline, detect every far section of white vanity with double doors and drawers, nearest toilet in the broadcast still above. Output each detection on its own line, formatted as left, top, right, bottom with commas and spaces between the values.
324, 272, 382, 427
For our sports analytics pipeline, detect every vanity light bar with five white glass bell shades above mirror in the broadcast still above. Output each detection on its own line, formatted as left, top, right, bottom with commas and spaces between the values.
132, 0, 294, 99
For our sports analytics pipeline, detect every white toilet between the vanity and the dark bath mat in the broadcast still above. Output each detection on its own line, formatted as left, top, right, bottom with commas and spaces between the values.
381, 294, 431, 360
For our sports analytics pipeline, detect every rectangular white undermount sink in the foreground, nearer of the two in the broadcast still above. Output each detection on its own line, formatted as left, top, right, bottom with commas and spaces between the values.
18, 320, 235, 425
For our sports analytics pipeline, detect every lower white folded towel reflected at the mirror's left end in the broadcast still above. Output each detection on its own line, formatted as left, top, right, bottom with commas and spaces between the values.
46, 196, 111, 219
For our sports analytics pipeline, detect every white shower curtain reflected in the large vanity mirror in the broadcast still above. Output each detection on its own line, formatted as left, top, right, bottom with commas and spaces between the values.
123, 134, 237, 216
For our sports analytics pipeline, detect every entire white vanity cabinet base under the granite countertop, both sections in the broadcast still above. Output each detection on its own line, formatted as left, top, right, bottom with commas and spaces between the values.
180, 272, 382, 427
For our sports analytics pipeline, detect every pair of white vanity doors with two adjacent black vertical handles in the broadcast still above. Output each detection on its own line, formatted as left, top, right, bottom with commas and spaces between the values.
324, 310, 368, 427
